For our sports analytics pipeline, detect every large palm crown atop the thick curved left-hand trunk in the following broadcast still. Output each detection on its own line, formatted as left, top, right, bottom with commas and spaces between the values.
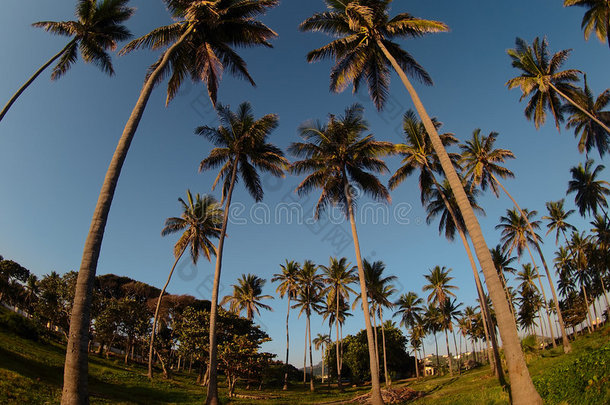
121, 0, 279, 105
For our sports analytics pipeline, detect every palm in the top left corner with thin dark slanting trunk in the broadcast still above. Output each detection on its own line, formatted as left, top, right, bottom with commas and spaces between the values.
0, 0, 135, 121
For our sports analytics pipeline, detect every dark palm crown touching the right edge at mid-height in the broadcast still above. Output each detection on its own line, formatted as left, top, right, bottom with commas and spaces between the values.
566, 159, 610, 217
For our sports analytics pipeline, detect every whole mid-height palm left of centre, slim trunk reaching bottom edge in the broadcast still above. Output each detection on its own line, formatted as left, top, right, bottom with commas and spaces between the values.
195, 102, 288, 405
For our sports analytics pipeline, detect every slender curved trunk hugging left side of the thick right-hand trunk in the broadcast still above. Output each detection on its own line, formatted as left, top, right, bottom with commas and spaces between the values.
433, 178, 504, 386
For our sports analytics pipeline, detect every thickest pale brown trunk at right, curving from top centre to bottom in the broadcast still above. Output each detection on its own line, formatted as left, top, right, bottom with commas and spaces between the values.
376, 38, 542, 405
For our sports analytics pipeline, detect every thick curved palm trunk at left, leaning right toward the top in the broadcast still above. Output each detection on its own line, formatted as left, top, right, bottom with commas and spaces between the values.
61, 28, 192, 405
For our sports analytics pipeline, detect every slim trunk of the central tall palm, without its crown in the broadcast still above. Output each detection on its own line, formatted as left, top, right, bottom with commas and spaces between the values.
337, 177, 383, 405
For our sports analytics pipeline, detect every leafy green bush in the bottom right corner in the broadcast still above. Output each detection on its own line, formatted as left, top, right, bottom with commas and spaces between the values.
534, 344, 610, 404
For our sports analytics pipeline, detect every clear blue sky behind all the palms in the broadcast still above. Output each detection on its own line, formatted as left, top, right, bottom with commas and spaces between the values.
0, 0, 610, 366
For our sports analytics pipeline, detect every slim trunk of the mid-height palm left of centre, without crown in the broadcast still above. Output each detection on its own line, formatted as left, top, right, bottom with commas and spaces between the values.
206, 159, 237, 405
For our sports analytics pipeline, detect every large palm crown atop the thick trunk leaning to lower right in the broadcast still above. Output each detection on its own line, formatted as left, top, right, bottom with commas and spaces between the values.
300, 0, 449, 110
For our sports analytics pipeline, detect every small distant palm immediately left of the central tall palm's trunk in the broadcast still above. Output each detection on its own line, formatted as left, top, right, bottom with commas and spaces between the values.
320, 257, 358, 390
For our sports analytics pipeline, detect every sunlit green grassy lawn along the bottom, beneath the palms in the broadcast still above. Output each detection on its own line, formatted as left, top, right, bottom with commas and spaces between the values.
0, 318, 610, 405
